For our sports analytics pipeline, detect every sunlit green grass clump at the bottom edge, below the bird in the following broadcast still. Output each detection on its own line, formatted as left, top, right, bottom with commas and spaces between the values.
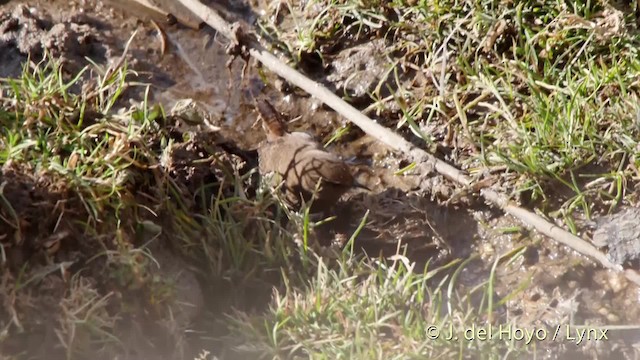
225, 249, 532, 359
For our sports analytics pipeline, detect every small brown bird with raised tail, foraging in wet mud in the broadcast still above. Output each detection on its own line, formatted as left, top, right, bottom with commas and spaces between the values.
256, 99, 362, 212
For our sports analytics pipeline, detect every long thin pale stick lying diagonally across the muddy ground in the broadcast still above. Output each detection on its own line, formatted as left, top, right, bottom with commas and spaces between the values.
175, 0, 640, 278
